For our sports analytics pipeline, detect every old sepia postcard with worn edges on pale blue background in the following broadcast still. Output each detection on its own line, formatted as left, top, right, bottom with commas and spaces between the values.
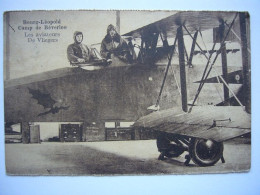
4, 10, 251, 175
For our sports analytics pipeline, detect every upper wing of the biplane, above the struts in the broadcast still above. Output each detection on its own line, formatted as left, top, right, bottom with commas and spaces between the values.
123, 11, 236, 38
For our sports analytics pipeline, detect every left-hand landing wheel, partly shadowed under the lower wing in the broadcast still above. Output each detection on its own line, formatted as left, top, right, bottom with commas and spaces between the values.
156, 134, 185, 158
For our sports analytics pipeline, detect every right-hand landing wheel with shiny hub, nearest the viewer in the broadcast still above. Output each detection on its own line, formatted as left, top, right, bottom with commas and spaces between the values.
189, 138, 224, 167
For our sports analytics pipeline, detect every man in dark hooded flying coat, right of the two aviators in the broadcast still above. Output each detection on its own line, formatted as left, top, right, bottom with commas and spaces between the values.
100, 24, 130, 61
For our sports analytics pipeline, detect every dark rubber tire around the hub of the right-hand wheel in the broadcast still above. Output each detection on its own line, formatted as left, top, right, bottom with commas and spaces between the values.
189, 138, 224, 167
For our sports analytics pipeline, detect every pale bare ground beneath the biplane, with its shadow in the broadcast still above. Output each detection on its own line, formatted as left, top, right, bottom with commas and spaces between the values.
5, 139, 251, 175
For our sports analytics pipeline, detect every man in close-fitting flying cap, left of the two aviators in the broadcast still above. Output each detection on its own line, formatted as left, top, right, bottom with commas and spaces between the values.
67, 31, 93, 64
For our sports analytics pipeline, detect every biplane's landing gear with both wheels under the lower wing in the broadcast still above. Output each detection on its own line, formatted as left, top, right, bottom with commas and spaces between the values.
157, 133, 225, 167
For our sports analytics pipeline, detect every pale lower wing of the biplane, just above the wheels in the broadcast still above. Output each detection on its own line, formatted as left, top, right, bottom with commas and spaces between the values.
134, 106, 251, 141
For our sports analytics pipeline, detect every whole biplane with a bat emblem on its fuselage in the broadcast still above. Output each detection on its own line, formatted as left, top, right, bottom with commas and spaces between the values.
5, 11, 251, 166
